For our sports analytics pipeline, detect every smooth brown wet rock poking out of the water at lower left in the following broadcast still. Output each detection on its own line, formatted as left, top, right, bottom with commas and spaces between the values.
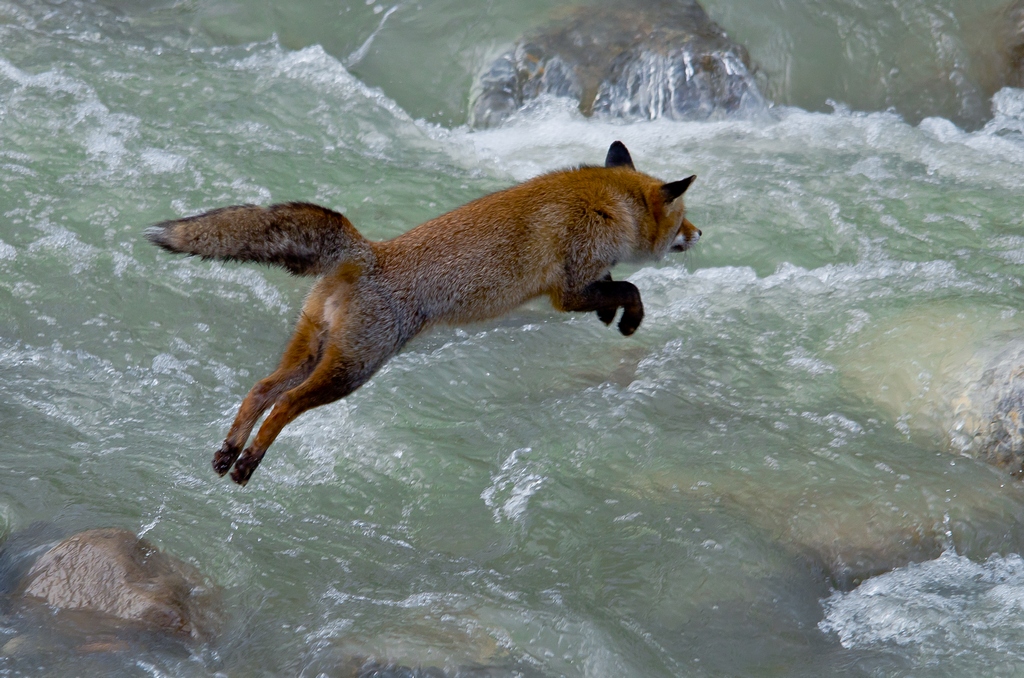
15, 528, 219, 639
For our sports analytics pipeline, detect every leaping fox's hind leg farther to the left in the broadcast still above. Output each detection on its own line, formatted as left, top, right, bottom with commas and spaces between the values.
213, 313, 323, 475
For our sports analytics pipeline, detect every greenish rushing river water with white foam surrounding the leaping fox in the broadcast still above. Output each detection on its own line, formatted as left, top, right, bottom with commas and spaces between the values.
0, 0, 1024, 677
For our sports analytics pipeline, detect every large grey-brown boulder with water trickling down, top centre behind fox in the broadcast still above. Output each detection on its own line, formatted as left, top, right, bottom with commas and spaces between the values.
470, 0, 767, 127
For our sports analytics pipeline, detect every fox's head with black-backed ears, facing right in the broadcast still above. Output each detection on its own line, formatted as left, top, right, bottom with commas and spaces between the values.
604, 141, 701, 258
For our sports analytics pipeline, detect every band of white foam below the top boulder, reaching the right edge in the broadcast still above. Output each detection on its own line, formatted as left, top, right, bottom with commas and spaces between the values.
428, 88, 1024, 188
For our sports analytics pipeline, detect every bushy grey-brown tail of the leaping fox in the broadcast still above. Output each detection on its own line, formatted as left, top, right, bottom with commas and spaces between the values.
145, 203, 374, 276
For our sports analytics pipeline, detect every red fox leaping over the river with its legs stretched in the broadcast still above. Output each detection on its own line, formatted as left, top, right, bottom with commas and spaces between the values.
146, 141, 700, 485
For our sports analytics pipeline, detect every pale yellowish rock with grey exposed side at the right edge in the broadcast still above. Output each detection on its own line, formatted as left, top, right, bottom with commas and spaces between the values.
839, 304, 1024, 475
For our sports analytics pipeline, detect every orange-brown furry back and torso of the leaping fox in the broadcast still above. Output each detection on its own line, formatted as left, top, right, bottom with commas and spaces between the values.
374, 168, 636, 323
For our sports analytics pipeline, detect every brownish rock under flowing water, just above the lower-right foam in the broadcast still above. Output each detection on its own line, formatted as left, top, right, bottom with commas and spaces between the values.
630, 469, 1024, 591
